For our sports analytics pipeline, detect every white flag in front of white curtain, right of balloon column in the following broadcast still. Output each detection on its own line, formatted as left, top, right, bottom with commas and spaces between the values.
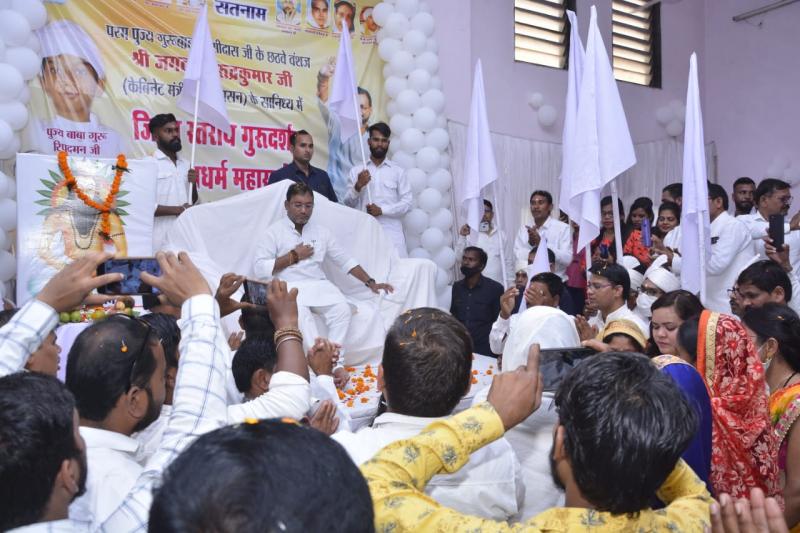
456, 59, 497, 233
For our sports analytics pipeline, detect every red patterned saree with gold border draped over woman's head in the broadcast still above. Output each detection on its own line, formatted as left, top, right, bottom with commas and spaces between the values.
696, 311, 780, 498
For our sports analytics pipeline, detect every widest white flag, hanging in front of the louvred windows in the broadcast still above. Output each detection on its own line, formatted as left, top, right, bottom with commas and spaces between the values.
567, 6, 636, 250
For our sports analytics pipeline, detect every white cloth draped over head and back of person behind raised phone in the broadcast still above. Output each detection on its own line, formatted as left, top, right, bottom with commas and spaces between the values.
472, 305, 580, 522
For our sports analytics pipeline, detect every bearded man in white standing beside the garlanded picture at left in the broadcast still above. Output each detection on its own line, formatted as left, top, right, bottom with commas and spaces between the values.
148, 113, 197, 252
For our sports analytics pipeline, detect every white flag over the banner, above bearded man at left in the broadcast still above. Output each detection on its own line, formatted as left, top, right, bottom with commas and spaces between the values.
178, 6, 230, 130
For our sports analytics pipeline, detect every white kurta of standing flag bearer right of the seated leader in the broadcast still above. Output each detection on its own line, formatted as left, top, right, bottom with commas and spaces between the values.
343, 158, 412, 257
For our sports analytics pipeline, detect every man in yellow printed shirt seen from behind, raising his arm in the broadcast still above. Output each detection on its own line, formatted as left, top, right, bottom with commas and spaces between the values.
361, 346, 712, 533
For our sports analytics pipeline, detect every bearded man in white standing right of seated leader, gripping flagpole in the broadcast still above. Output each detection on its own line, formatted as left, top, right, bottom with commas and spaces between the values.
344, 122, 412, 257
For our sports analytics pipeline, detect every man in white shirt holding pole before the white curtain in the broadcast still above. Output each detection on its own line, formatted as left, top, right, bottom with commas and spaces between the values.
514, 191, 572, 279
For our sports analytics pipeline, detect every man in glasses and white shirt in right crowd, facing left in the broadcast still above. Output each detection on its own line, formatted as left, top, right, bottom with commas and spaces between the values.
576, 263, 650, 340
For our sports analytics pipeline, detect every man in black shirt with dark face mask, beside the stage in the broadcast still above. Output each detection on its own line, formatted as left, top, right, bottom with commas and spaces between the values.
450, 246, 503, 357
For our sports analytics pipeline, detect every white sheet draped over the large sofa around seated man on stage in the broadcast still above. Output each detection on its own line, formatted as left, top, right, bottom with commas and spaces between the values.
169, 180, 436, 365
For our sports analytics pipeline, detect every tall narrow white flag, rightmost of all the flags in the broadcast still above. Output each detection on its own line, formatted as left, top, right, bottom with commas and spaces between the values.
681, 53, 711, 302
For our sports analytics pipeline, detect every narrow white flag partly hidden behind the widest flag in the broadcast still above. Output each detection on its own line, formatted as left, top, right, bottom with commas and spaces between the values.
558, 10, 586, 220
